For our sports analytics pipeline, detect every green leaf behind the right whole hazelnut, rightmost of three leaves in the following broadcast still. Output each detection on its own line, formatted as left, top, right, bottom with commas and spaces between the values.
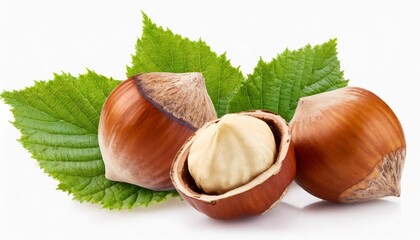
228, 39, 348, 121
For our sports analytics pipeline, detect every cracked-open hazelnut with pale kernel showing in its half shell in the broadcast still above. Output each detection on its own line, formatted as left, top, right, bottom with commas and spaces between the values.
171, 110, 296, 219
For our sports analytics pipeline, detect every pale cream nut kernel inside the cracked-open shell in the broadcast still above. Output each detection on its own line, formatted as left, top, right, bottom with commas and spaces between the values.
188, 114, 276, 194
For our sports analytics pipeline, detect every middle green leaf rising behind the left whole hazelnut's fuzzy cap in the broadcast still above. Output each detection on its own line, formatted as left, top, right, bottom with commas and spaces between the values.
127, 14, 244, 117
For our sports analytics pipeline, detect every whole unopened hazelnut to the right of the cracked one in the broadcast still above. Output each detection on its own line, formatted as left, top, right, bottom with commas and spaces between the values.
290, 87, 406, 203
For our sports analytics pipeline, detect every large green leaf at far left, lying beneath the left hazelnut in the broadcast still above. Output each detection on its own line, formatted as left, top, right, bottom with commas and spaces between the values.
1, 71, 177, 209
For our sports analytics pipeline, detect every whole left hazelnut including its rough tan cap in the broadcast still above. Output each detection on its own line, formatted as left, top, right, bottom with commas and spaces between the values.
98, 73, 217, 190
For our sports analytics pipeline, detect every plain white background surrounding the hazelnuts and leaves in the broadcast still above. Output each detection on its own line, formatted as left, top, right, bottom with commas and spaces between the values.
0, 0, 420, 239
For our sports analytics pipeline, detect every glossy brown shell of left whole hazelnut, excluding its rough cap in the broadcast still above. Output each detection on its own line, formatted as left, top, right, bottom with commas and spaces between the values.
98, 79, 194, 190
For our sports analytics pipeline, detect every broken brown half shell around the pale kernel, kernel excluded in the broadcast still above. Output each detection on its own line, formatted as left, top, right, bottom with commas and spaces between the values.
171, 110, 296, 220
